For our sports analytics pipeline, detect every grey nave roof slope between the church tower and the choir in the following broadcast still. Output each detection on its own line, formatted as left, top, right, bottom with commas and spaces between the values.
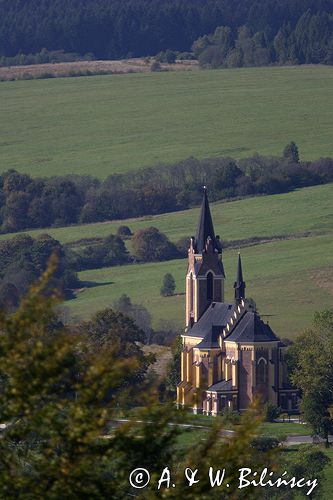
186, 302, 235, 339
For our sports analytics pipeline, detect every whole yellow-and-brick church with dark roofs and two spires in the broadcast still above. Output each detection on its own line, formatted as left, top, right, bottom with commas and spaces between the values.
177, 189, 298, 415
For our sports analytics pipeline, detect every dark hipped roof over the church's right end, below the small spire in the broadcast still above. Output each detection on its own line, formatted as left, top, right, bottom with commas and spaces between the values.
225, 311, 279, 342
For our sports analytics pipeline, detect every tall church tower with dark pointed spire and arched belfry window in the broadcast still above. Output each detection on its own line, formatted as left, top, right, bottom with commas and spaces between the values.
186, 187, 225, 328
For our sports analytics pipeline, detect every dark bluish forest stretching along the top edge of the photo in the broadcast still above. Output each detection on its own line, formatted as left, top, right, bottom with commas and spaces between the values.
0, 0, 333, 62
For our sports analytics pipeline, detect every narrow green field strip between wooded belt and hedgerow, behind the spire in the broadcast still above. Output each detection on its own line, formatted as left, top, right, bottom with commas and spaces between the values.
0, 184, 333, 243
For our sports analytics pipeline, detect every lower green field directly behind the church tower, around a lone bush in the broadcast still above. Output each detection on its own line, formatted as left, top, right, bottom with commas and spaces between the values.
67, 234, 333, 337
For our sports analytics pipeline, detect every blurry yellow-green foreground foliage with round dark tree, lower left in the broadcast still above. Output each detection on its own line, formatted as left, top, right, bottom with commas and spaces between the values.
0, 260, 282, 500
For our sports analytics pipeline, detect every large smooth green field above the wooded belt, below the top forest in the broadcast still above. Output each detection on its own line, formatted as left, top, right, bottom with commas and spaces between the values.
0, 65, 333, 178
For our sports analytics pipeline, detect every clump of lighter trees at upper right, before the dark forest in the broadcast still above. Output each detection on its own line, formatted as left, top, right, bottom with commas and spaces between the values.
192, 10, 333, 68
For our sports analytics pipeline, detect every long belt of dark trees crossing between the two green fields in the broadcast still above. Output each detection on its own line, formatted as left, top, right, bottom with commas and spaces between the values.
0, 148, 333, 233
